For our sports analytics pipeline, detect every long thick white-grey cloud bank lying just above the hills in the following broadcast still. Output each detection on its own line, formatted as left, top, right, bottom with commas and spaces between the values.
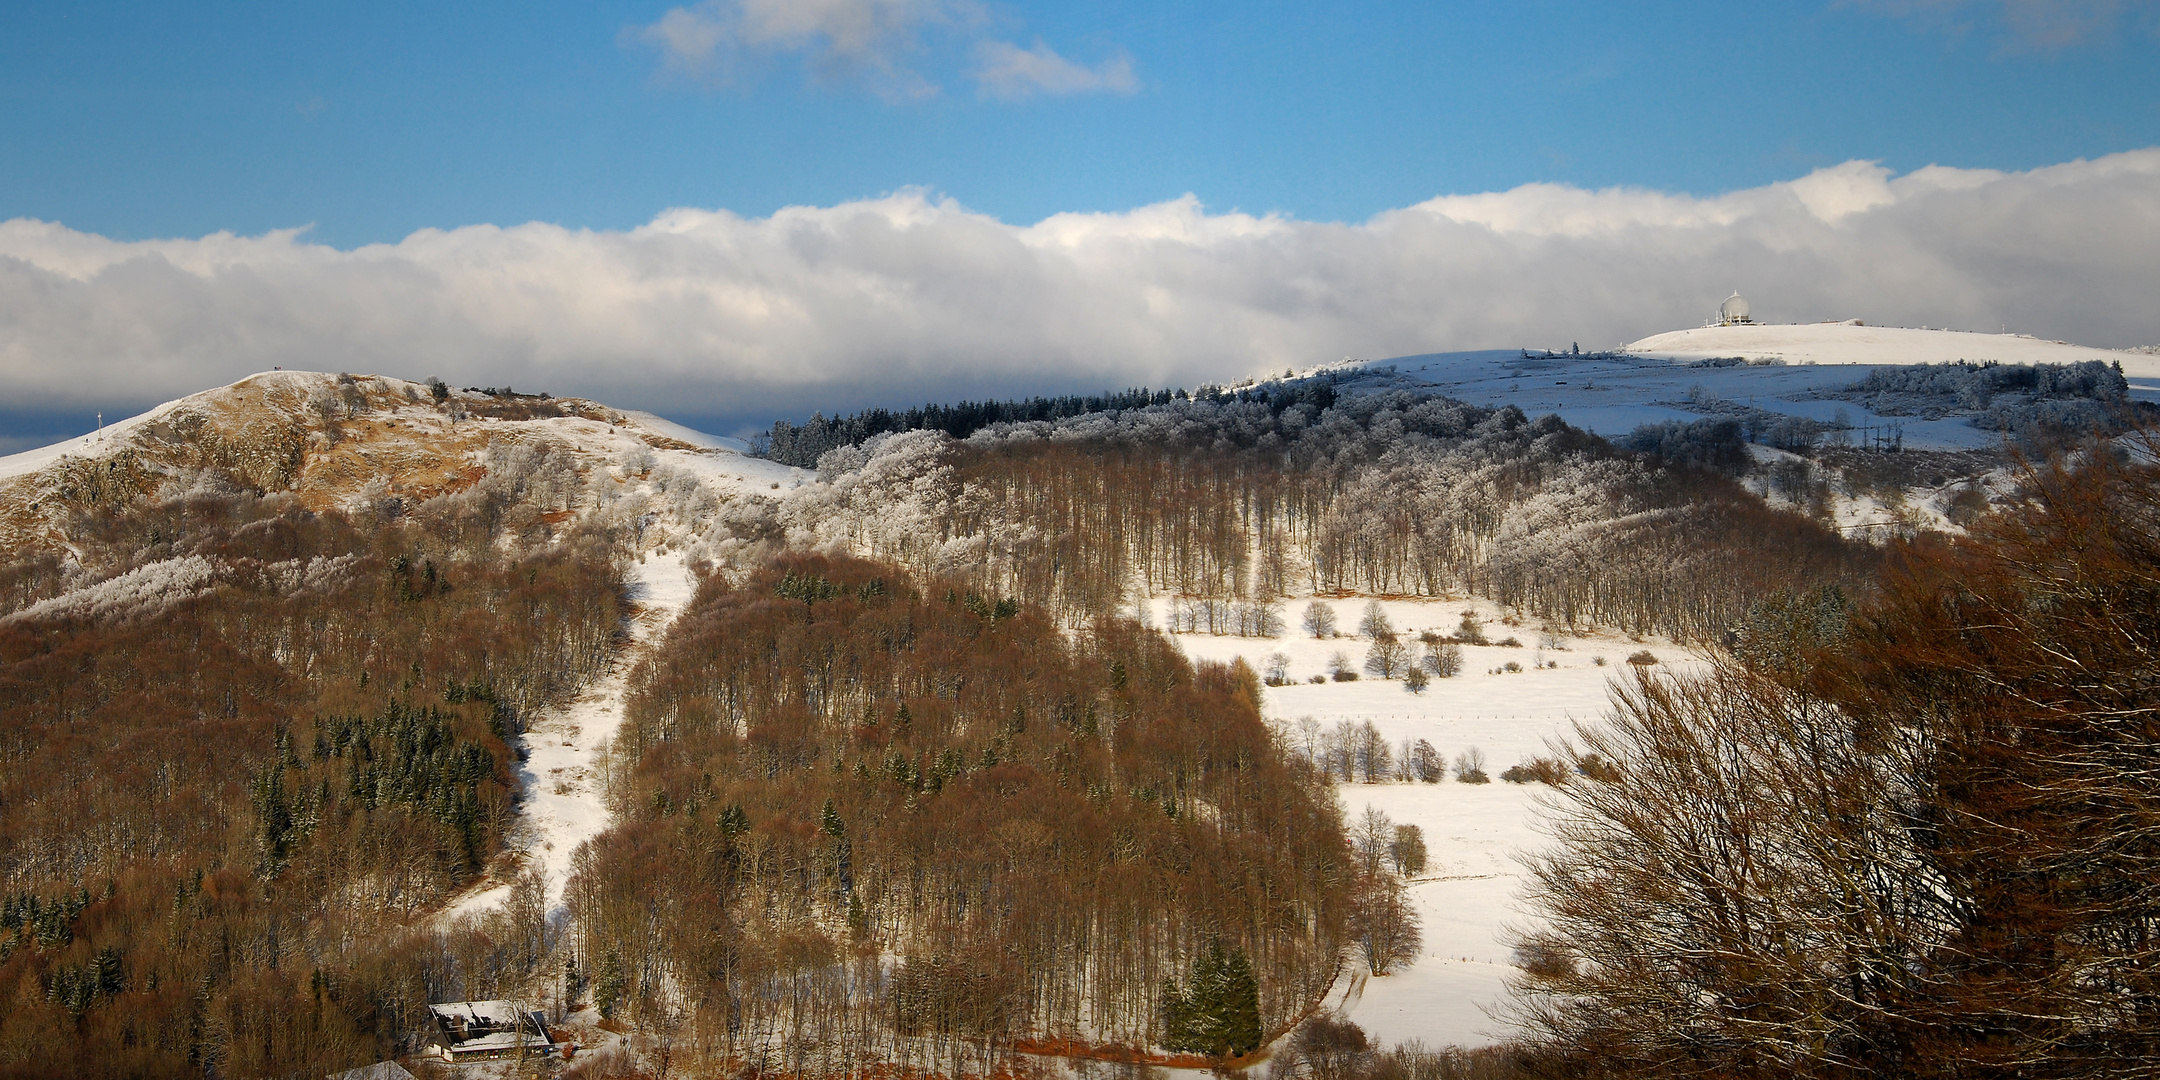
0, 149, 2160, 429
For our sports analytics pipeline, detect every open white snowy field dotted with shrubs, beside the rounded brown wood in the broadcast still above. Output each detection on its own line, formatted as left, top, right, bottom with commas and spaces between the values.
1151, 598, 1704, 1045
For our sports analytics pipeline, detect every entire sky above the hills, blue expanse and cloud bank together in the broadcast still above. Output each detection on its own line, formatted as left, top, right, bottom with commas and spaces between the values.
0, 0, 2160, 442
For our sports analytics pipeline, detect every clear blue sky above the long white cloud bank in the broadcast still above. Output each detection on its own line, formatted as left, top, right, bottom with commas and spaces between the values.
0, 0, 2160, 248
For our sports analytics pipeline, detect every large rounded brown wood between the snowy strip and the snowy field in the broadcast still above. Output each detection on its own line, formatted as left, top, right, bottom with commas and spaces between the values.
568, 555, 1361, 1076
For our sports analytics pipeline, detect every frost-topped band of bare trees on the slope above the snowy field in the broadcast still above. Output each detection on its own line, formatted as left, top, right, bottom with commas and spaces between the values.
773, 391, 1871, 639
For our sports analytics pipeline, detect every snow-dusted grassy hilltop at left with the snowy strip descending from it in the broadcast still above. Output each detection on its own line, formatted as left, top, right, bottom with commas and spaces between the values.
0, 372, 797, 941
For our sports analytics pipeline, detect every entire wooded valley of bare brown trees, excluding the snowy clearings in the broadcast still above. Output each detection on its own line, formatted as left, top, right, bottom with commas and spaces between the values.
0, 365, 2134, 1080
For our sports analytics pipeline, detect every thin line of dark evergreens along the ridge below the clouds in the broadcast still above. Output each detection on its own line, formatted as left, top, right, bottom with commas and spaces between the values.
750, 378, 1335, 469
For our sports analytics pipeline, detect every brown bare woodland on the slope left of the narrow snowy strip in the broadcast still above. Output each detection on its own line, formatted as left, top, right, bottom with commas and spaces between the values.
0, 475, 620, 1078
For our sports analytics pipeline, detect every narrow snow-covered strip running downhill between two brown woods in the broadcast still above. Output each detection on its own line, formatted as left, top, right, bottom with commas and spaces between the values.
443, 553, 698, 920
